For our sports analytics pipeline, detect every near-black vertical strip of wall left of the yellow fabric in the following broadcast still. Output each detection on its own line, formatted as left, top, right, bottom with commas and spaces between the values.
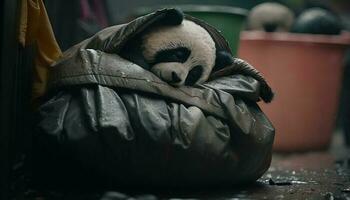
0, 0, 21, 199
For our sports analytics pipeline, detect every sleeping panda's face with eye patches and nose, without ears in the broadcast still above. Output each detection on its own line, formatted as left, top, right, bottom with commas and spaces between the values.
141, 20, 216, 86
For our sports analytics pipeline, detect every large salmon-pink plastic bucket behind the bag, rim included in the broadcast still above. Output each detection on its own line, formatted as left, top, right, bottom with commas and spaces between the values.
238, 32, 350, 152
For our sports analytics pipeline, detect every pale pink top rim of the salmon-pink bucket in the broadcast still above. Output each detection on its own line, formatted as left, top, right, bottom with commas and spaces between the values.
241, 31, 350, 47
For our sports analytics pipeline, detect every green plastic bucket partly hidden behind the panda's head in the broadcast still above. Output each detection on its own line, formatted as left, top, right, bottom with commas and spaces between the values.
136, 5, 248, 55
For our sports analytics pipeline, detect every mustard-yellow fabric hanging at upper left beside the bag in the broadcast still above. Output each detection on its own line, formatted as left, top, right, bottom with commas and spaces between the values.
19, 0, 62, 100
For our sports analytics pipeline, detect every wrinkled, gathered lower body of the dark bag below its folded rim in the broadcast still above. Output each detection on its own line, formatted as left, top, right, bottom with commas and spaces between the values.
34, 75, 274, 187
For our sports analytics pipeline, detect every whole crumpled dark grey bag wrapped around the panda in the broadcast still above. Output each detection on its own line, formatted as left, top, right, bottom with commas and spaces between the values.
34, 9, 274, 188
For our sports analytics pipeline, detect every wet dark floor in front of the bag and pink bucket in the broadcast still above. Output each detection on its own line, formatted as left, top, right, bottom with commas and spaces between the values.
23, 135, 350, 200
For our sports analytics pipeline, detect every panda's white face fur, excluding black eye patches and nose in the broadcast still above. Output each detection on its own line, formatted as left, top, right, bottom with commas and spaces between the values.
142, 20, 216, 85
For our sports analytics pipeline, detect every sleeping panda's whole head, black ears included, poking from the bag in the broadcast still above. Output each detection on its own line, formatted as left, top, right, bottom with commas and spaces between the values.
118, 9, 234, 86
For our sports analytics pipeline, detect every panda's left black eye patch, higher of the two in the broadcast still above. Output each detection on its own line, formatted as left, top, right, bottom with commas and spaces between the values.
153, 47, 191, 64
